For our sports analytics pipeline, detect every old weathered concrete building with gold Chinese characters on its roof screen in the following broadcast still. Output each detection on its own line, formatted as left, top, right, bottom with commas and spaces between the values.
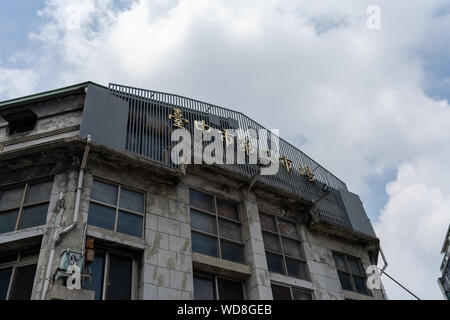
0, 82, 385, 300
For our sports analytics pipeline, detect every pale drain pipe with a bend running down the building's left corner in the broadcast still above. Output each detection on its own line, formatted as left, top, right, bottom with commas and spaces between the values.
41, 135, 92, 300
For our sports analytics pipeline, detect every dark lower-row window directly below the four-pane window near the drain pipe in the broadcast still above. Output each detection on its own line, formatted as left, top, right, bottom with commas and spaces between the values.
83, 250, 137, 300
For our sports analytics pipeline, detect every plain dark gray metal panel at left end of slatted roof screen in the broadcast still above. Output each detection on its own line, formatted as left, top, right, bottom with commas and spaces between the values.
80, 85, 128, 151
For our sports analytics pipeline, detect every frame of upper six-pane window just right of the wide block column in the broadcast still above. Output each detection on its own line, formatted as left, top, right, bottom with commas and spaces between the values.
189, 187, 248, 265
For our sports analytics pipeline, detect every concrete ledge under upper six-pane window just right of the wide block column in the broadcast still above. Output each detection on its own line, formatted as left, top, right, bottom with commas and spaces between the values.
192, 252, 252, 279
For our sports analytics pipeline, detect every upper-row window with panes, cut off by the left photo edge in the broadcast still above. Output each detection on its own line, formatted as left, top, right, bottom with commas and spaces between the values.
0, 181, 53, 233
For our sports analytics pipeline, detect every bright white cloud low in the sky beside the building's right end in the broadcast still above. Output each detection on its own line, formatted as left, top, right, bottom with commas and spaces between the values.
375, 163, 450, 299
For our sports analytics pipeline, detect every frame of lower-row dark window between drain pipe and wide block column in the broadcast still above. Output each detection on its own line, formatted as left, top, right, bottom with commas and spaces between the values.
82, 246, 139, 301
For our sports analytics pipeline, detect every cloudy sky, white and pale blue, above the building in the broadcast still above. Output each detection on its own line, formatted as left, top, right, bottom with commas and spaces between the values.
0, 0, 450, 299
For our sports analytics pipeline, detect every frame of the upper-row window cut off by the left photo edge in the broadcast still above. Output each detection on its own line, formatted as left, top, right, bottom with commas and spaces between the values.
0, 176, 54, 234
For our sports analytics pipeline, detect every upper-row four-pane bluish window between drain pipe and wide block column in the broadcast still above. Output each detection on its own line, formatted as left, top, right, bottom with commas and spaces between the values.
88, 179, 144, 238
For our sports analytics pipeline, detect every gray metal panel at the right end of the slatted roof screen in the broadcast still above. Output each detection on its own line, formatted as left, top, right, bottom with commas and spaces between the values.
339, 189, 376, 237
